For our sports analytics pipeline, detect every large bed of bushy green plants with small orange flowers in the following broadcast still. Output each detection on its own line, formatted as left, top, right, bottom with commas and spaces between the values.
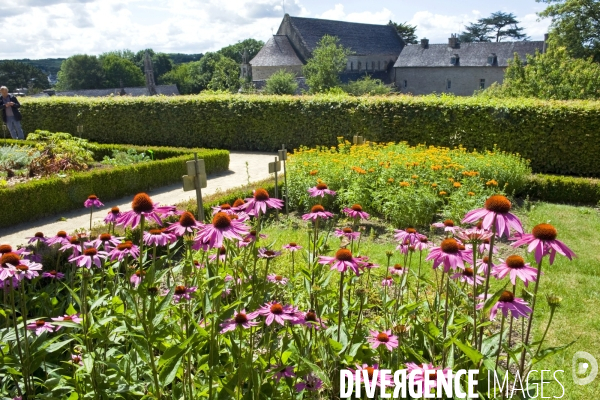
288, 142, 530, 228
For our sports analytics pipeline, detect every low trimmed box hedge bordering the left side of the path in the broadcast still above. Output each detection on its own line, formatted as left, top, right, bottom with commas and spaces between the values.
0, 141, 229, 227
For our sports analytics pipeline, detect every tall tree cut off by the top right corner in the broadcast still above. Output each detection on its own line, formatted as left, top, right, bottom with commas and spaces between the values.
536, 0, 600, 62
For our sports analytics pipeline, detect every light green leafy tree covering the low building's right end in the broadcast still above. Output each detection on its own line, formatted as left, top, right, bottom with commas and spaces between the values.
482, 47, 600, 100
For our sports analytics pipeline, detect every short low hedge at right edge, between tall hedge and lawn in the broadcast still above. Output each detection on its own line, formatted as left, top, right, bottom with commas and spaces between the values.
521, 174, 600, 205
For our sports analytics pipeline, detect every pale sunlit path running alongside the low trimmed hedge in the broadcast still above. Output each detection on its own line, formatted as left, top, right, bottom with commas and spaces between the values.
0, 152, 277, 247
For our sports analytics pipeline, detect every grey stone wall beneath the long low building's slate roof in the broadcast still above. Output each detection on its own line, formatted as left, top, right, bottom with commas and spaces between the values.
394, 67, 504, 96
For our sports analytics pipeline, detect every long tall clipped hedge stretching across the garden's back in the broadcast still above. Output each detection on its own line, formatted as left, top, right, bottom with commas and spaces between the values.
21, 95, 600, 176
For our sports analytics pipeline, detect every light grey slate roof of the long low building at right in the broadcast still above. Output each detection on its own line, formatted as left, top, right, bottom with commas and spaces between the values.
394, 41, 544, 68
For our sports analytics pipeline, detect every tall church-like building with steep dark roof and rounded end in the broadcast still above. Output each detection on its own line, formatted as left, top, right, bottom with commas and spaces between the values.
248, 14, 404, 83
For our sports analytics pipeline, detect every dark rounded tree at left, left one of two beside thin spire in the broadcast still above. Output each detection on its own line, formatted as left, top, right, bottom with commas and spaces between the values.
56, 54, 105, 90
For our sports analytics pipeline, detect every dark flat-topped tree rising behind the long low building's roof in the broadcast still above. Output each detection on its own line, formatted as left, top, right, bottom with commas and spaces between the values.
459, 11, 529, 42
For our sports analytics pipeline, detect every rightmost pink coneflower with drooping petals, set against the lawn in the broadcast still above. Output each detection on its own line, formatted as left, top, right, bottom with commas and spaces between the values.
512, 224, 576, 265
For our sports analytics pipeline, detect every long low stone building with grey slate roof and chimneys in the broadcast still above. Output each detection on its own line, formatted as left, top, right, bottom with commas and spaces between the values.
394, 35, 545, 96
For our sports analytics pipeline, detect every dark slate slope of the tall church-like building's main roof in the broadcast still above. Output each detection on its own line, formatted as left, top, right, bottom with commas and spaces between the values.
284, 17, 403, 57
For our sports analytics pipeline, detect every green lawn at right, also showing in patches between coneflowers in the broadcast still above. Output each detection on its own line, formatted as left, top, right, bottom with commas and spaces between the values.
262, 203, 600, 400
